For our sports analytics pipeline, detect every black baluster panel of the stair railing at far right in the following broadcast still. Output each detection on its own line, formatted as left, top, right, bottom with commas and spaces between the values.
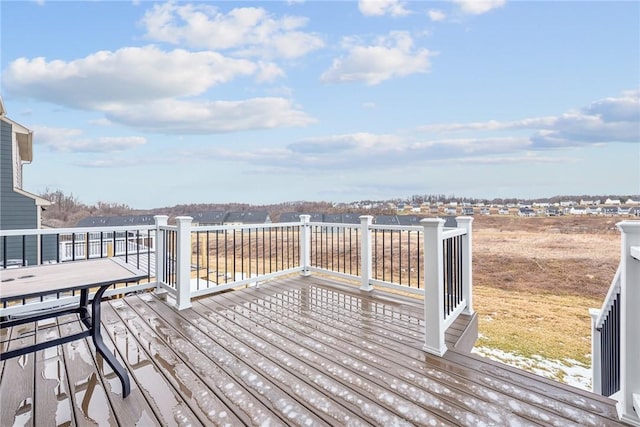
598, 292, 620, 396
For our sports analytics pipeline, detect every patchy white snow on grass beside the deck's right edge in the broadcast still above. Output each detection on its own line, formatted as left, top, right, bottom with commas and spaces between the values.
471, 347, 591, 391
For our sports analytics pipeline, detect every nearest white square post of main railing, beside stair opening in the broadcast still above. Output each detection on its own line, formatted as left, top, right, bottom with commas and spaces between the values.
420, 218, 447, 356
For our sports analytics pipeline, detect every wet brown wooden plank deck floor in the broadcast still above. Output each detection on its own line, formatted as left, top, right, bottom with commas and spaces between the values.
0, 277, 621, 426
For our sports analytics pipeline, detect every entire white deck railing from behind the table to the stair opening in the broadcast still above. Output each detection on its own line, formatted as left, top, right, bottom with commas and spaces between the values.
0, 215, 473, 355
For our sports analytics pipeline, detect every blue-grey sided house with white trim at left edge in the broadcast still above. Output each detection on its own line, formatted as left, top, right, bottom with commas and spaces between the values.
0, 97, 55, 265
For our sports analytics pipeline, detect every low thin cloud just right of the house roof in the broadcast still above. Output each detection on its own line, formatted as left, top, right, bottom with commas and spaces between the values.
34, 126, 147, 153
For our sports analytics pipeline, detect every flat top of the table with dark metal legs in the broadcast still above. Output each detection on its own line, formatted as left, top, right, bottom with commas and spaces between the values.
0, 258, 149, 301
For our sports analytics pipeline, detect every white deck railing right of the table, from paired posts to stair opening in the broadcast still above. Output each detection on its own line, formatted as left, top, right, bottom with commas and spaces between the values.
151, 215, 473, 355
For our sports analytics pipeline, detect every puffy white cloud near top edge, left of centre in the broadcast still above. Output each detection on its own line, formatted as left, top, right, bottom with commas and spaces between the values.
141, 2, 324, 58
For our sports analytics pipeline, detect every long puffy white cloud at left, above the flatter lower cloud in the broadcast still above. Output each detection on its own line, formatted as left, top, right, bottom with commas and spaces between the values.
3, 46, 258, 111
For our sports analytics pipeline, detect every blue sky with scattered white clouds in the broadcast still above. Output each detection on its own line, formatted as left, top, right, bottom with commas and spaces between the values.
0, 0, 640, 209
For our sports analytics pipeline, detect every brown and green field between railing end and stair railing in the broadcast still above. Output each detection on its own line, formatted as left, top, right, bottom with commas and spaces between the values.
473, 216, 622, 380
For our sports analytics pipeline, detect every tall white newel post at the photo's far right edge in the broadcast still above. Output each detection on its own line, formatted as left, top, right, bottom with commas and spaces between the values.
617, 221, 640, 425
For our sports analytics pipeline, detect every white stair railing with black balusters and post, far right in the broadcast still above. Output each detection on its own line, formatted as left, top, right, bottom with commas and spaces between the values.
589, 221, 640, 426
